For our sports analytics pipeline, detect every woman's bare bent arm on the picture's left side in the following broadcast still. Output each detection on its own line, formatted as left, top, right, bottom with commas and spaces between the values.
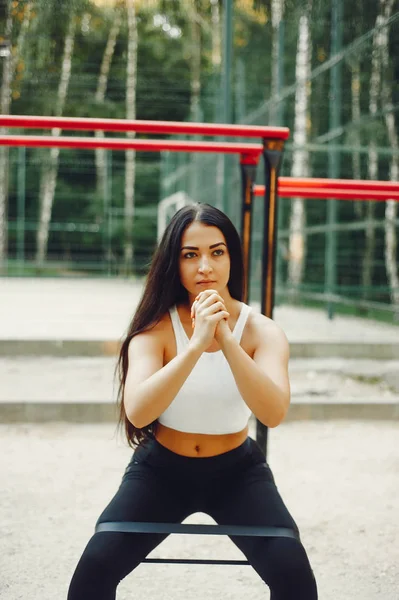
123, 328, 202, 428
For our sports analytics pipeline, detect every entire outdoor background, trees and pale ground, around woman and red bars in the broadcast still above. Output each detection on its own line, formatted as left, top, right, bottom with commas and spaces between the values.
0, 5, 399, 600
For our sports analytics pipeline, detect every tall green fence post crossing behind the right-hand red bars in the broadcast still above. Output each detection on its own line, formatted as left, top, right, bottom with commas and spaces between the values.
324, 0, 343, 319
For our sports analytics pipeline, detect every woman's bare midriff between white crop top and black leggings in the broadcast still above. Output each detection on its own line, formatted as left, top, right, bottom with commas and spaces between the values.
155, 423, 248, 458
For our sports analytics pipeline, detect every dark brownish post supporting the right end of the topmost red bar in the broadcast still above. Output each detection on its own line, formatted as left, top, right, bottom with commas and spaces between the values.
256, 139, 284, 456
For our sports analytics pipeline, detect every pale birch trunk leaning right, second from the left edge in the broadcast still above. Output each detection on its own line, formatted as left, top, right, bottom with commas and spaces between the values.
36, 13, 76, 268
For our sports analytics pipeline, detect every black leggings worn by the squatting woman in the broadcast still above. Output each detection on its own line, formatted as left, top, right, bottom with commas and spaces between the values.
68, 438, 317, 600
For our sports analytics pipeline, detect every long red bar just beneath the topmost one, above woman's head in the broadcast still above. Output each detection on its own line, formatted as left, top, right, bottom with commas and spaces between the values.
0, 135, 263, 155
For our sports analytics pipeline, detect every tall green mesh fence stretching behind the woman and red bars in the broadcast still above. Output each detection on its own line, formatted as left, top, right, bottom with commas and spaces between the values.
4, 0, 399, 320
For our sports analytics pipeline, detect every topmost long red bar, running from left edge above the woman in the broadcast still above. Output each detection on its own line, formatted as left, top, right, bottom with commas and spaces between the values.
0, 115, 290, 140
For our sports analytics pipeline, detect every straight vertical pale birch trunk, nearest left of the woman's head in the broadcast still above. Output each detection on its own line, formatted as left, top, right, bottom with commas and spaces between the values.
124, 0, 138, 275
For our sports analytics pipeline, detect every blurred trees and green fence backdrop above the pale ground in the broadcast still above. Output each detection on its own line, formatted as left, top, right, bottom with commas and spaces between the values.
0, 0, 399, 322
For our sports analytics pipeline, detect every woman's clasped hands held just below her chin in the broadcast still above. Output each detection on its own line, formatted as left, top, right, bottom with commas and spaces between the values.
190, 290, 230, 352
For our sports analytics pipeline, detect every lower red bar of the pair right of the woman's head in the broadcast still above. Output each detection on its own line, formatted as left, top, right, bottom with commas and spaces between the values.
254, 184, 399, 201
